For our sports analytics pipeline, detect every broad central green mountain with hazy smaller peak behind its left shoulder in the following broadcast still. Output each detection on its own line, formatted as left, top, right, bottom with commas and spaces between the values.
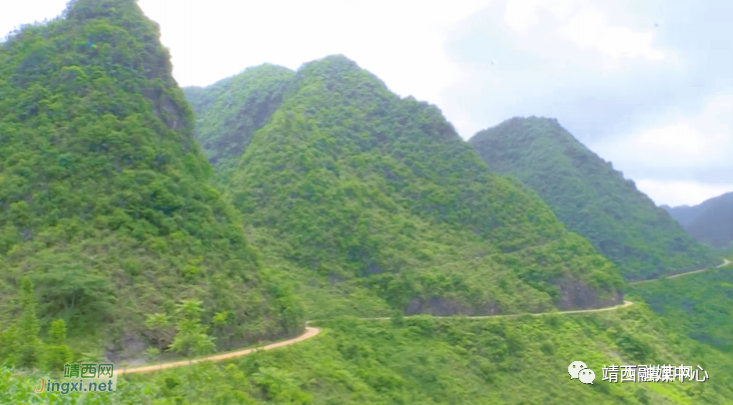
186, 55, 621, 319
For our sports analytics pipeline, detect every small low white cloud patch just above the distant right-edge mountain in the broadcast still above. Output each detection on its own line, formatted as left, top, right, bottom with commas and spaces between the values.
636, 179, 733, 207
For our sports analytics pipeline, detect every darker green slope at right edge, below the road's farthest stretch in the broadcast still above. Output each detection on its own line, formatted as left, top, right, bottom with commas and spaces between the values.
629, 264, 733, 354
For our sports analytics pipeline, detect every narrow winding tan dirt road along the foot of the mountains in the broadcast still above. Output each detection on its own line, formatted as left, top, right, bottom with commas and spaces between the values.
117, 259, 730, 376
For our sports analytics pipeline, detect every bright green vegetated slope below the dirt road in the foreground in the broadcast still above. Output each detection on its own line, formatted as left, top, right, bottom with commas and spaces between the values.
5, 305, 733, 405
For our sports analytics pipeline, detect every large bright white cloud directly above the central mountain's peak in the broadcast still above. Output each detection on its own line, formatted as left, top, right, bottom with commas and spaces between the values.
140, 0, 486, 104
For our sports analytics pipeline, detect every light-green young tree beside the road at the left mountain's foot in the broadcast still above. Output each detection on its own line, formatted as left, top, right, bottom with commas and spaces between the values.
169, 300, 216, 357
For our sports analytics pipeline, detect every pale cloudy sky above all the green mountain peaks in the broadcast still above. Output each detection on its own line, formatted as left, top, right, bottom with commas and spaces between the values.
0, 0, 733, 205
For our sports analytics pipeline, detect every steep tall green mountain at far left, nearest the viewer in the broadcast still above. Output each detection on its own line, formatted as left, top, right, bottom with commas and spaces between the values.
0, 0, 302, 361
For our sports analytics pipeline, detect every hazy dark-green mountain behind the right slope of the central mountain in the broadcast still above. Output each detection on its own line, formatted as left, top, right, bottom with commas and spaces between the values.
469, 117, 717, 281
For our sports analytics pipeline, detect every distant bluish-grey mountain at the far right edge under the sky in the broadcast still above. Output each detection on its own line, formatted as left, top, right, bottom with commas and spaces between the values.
664, 192, 733, 248
